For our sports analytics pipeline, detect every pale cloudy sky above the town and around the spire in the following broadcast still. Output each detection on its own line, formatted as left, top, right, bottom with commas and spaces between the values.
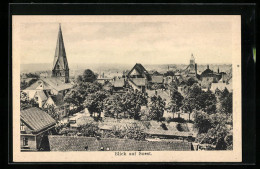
14, 16, 240, 64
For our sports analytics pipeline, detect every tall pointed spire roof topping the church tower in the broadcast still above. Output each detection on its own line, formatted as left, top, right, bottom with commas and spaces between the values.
52, 23, 69, 70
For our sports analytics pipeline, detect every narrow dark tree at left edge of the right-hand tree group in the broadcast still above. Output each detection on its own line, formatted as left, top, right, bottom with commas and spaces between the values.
168, 90, 183, 118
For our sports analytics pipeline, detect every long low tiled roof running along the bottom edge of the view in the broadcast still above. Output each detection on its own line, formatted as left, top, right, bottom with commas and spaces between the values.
48, 135, 192, 151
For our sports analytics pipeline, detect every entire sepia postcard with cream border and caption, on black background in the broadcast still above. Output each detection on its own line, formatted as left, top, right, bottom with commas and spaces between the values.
12, 15, 242, 162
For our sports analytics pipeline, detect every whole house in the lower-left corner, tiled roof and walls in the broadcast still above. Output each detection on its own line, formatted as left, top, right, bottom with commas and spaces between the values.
20, 107, 56, 151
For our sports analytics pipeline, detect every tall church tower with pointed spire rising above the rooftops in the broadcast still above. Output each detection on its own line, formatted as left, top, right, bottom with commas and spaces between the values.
52, 25, 69, 83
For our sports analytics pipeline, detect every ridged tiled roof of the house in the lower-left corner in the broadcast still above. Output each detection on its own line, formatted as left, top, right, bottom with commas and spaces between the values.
20, 107, 56, 132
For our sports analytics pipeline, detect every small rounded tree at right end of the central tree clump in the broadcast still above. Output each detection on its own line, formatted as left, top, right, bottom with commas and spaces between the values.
148, 96, 165, 121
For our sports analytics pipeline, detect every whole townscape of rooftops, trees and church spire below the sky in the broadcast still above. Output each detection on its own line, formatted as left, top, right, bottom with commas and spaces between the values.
20, 25, 233, 151
